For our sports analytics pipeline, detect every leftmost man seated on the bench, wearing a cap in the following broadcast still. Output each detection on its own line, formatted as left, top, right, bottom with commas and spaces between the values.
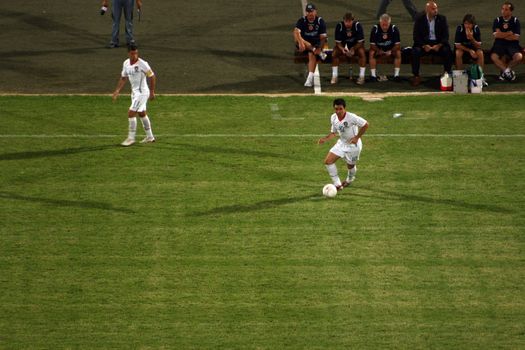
293, 3, 327, 87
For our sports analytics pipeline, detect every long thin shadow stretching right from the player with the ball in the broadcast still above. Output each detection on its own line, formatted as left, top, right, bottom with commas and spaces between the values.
352, 187, 515, 214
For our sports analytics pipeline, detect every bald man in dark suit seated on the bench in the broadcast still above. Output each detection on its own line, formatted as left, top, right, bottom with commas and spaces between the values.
412, 1, 452, 86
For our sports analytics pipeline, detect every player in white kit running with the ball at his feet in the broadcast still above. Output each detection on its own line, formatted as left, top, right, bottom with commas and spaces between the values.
318, 98, 368, 191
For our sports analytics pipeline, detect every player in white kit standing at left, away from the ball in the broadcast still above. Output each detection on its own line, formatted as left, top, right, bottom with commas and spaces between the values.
113, 45, 156, 146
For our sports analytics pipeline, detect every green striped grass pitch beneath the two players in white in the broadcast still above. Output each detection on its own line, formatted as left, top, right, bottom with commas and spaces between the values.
0, 95, 525, 349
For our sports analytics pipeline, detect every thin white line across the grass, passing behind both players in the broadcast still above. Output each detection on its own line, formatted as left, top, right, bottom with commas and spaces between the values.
0, 134, 525, 139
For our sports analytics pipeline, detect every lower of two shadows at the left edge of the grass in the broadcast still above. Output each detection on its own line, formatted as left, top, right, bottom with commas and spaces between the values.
0, 191, 136, 214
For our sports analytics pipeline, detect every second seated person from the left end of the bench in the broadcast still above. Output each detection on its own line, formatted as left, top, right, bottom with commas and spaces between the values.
331, 12, 366, 85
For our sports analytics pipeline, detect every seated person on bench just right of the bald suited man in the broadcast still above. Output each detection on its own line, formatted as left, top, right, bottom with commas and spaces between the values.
454, 13, 485, 70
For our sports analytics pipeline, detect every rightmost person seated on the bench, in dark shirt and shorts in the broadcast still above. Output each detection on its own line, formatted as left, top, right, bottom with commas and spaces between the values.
490, 1, 523, 81
